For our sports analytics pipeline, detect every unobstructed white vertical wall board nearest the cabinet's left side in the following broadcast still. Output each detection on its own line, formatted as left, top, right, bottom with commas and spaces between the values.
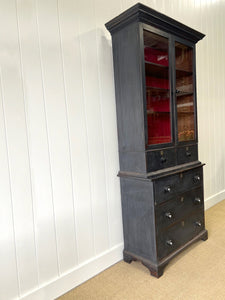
77, 0, 109, 254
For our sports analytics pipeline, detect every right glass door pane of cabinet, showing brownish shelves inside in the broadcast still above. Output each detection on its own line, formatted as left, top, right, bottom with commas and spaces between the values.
175, 43, 195, 142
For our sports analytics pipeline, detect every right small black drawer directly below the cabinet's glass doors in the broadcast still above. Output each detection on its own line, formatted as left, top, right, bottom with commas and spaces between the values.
177, 145, 198, 165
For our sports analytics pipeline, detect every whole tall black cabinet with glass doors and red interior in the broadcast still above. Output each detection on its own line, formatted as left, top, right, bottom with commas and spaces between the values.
106, 3, 207, 277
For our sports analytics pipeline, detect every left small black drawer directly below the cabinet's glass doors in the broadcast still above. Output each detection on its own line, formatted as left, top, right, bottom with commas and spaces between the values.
146, 148, 176, 172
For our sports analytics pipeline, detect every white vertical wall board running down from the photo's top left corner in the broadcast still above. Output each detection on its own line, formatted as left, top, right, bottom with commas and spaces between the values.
0, 1, 38, 293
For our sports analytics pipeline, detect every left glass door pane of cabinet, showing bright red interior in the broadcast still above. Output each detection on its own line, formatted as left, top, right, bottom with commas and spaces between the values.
144, 30, 172, 145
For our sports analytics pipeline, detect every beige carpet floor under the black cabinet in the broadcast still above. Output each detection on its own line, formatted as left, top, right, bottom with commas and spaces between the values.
58, 200, 225, 300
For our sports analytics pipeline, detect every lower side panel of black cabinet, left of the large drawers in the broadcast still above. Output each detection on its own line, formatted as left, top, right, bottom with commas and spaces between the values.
121, 178, 156, 262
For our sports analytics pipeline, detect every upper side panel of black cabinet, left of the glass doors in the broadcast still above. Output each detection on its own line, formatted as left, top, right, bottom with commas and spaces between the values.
112, 23, 145, 156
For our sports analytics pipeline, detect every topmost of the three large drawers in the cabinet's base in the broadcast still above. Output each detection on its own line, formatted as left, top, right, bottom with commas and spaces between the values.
154, 166, 203, 204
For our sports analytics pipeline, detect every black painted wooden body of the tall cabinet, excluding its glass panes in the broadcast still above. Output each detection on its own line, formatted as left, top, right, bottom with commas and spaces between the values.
106, 3, 208, 277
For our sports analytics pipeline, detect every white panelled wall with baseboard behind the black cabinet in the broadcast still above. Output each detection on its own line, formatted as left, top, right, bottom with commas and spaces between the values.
0, 0, 225, 300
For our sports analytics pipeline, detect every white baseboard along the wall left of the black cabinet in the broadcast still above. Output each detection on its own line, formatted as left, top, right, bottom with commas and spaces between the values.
19, 243, 123, 300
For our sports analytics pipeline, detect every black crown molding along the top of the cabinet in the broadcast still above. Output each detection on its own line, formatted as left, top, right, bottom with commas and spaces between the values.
105, 3, 205, 43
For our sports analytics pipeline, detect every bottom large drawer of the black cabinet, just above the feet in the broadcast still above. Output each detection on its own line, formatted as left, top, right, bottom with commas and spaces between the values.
157, 213, 205, 259
